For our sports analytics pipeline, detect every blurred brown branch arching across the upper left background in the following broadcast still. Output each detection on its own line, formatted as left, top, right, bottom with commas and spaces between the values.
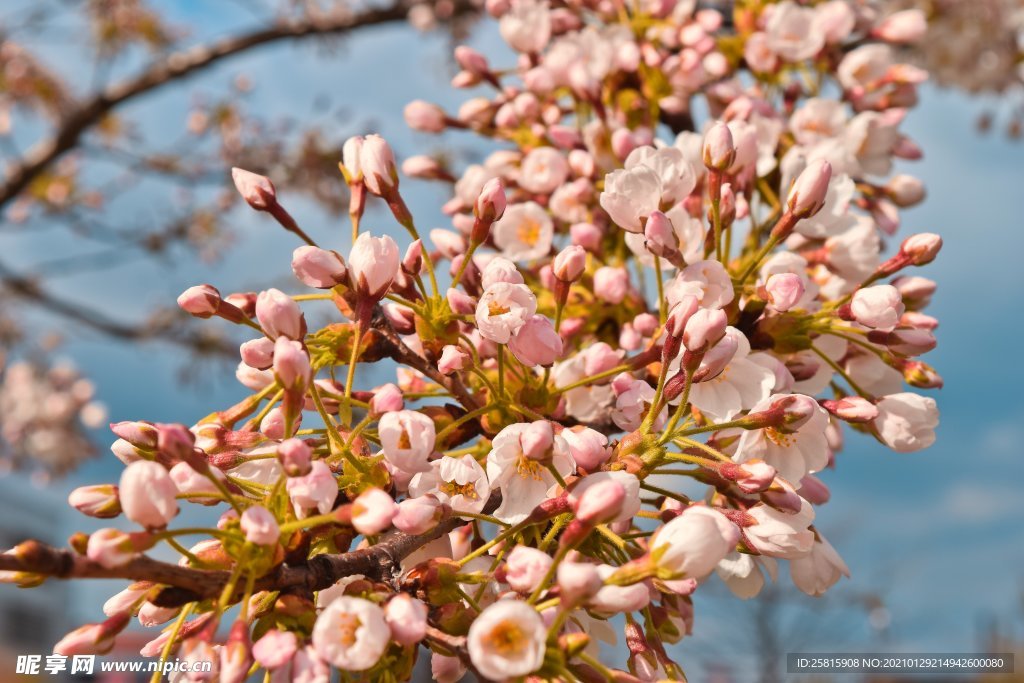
0, 0, 473, 209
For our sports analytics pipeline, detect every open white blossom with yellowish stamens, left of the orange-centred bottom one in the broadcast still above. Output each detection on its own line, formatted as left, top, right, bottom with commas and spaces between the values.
312, 595, 391, 671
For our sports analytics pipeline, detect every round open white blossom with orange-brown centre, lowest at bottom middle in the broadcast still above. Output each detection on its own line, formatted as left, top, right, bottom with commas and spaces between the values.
466, 600, 548, 681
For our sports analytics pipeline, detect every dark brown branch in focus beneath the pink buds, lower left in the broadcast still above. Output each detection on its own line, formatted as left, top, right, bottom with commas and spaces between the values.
0, 494, 501, 607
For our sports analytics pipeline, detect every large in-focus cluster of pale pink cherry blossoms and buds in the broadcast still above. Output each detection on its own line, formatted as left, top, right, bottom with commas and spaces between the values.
5, 0, 942, 681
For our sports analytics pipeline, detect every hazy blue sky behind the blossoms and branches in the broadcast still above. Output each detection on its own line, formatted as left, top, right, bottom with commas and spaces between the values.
4, 2, 1024, 679
